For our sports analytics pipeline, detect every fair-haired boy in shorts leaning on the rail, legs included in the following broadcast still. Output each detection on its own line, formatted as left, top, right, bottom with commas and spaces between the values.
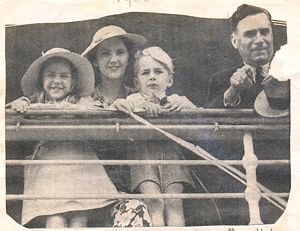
117, 47, 196, 226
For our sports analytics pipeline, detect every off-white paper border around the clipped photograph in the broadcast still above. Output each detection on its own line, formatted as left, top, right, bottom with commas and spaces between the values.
0, 0, 300, 231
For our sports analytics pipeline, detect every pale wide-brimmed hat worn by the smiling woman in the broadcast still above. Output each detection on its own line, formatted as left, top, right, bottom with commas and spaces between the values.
81, 25, 147, 57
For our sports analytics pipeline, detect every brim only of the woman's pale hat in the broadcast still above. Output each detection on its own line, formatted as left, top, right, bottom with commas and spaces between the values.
81, 33, 147, 57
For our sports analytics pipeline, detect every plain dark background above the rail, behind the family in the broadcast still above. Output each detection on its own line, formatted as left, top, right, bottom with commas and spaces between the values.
6, 13, 287, 106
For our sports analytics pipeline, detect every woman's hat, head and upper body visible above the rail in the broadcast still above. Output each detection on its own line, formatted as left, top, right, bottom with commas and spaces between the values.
81, 25, 147, 107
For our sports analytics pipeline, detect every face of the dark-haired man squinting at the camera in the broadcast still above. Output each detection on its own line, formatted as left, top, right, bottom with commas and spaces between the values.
231, 13, 273, 67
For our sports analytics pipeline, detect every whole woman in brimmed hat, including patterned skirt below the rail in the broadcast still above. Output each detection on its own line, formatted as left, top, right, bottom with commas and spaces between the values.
82, 25, 151, 227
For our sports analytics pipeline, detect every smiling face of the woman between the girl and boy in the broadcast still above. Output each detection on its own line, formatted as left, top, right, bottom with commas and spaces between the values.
96, 38, 128, 80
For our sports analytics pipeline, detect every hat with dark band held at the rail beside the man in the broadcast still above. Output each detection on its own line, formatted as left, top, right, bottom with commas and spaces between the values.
254, 78, 290, 117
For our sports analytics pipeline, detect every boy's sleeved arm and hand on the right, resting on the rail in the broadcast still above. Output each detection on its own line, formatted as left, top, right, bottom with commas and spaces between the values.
164, 94, 197, 112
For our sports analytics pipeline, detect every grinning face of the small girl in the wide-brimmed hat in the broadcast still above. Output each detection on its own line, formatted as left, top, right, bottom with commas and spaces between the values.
42, 61, 73, 101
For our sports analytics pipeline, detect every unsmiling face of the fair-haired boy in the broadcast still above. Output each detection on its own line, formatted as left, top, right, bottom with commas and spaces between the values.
135, 56, 173, 96
